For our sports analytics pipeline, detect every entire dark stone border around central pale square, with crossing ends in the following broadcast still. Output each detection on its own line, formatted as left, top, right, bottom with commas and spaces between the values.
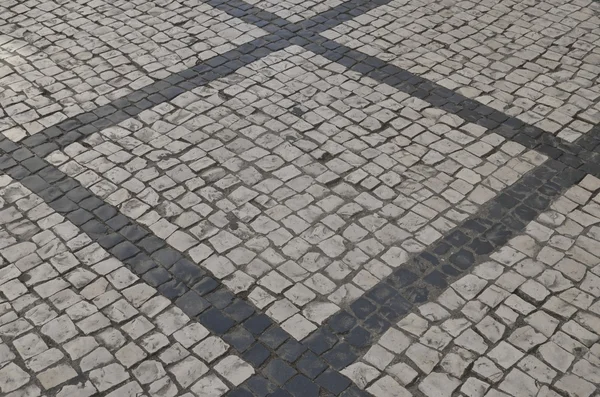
0, 0, 600, 397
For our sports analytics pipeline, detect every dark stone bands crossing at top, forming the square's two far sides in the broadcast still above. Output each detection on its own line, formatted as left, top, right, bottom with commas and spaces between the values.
11, 0, 600, 184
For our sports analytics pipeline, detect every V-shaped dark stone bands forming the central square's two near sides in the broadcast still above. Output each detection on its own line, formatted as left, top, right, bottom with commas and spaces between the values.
0, 134, 585, 396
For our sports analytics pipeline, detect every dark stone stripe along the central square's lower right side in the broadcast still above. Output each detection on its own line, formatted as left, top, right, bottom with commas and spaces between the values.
318, 160, 586, 358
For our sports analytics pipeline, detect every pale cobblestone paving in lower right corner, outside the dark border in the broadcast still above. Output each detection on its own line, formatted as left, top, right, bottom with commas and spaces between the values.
342, 177, 600, 396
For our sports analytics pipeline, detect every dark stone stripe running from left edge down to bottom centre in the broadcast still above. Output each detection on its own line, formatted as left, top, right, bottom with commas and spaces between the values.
0, 138, 360, 397
